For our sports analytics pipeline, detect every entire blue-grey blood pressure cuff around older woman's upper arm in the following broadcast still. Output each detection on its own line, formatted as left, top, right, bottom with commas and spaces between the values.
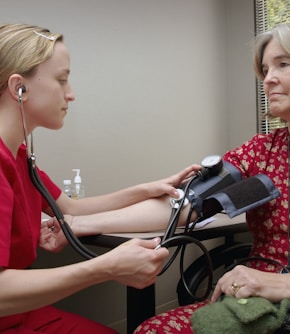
186, 161, 280, 221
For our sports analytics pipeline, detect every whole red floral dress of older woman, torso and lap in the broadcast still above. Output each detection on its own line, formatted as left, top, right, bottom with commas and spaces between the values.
134, 128, 289, 334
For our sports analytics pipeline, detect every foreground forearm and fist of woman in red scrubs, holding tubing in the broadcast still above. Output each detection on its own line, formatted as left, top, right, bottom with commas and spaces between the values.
0, 238, 169, 316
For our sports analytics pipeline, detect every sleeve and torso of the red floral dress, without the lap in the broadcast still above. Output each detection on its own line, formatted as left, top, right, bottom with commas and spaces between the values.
224, 128, 289, 272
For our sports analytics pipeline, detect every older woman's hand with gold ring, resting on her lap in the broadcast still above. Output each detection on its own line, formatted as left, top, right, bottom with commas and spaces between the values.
211, 265, 290, 302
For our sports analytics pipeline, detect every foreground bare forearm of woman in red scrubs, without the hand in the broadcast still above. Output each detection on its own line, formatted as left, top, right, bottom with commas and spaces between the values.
0, 262, 106, 316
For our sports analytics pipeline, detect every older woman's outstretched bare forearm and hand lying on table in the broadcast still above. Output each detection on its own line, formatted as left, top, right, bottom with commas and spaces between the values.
40, 196, 196, 244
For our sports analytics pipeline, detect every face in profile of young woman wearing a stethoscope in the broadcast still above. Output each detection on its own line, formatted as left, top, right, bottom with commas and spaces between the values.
24, 42, 75, 132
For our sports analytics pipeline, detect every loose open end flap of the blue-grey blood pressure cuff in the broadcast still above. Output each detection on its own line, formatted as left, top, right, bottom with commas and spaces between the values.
204, 174, 280, 218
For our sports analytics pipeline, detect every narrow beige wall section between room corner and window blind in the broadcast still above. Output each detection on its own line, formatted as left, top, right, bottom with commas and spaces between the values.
226, 0, 257, 149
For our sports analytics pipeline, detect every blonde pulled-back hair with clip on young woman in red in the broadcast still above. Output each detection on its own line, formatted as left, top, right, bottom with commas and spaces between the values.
0, 24, 63, 96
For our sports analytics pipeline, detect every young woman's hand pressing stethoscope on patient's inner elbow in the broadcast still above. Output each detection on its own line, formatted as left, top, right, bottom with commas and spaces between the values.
145, 165, 201, 198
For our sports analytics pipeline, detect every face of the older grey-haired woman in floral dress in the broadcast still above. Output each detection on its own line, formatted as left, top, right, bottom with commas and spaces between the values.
262, 39, 290, 122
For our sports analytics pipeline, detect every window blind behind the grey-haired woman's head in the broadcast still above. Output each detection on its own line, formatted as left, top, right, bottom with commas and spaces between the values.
255, 0, 290, 133
